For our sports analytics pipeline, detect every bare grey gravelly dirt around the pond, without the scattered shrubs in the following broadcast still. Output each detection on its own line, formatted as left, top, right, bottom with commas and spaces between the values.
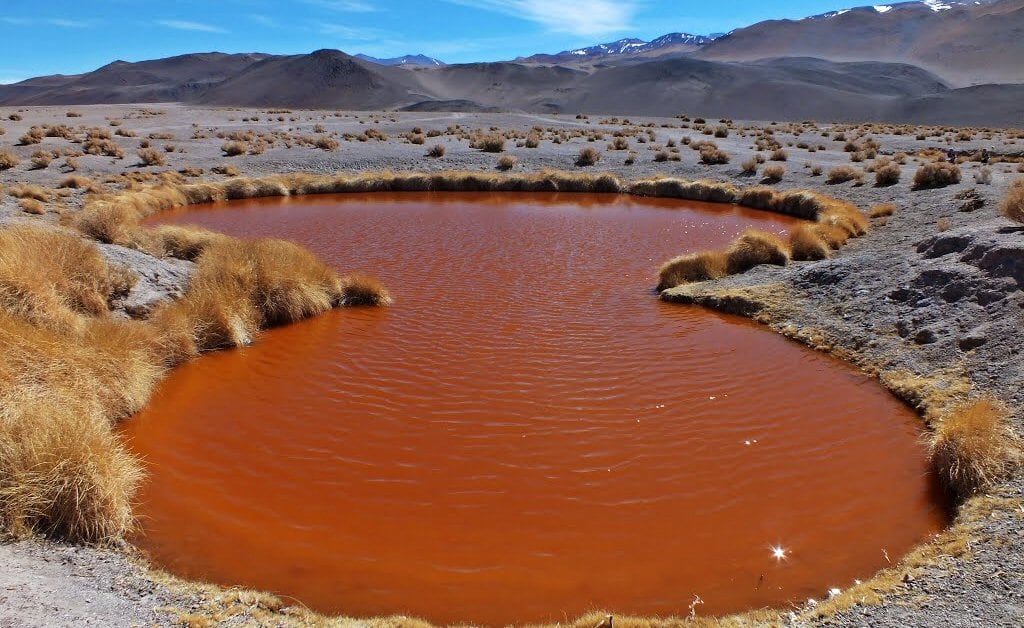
0, 104, 1024, 626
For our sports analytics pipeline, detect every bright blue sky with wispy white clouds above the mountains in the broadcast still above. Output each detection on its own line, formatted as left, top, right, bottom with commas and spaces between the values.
0, 0, 857, 83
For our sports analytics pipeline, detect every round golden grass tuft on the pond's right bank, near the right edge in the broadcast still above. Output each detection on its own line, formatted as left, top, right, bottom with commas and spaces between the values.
931, 399, 1020, 499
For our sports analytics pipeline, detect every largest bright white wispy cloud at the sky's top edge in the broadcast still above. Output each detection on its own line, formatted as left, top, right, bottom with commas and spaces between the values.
445, 0, 637, 36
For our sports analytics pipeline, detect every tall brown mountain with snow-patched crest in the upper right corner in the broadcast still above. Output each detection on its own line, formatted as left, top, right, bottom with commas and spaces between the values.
695, 0, 1024, 86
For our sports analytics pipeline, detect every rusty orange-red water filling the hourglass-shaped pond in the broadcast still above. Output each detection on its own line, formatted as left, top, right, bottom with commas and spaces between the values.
124, 194, 946, 624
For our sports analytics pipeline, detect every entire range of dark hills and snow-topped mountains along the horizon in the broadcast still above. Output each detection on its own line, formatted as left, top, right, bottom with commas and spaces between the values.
0, 0, 1024, 126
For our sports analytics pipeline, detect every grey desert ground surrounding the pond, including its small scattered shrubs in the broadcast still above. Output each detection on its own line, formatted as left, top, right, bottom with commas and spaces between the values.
0, 103, 1024, 627
